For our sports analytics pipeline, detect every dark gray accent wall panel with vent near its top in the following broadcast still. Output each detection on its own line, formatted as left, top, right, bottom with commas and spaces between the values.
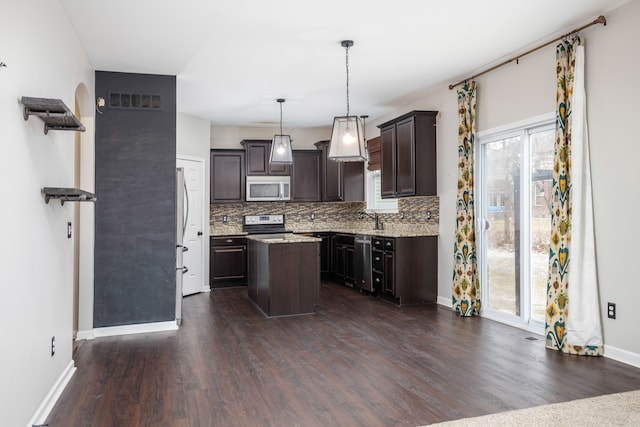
93, 71, 176, 328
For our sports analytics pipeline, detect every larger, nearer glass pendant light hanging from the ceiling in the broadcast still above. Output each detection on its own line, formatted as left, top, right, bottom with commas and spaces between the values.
328, 40, 367, 162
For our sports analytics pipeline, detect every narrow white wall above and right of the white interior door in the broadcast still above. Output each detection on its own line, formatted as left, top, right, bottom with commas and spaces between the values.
176, 113, 211, 290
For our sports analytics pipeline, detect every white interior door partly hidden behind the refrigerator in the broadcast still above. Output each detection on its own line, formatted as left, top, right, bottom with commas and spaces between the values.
176, 157, 204, 295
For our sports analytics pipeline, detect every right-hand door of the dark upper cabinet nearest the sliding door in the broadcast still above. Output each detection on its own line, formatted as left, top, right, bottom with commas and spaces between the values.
396, 117, 416, 196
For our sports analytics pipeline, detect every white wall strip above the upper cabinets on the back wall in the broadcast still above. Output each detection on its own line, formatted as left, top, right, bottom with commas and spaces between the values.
211, 125, 331, 150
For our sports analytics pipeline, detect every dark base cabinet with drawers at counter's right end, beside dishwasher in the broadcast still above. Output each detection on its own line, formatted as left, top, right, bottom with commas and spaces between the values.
371, 236, 438, 305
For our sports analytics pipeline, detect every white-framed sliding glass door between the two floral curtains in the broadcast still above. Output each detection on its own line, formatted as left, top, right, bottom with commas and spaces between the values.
478, 120, 554, 332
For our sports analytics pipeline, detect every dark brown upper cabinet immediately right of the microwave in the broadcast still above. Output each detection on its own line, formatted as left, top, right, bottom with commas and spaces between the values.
291, 150, 322, 202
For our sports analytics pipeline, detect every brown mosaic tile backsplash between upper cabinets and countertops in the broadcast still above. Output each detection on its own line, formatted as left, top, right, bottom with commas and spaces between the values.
210, 196, 440, 235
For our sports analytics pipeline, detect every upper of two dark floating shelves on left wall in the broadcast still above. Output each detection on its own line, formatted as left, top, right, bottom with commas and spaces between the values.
20, 96, 85, 135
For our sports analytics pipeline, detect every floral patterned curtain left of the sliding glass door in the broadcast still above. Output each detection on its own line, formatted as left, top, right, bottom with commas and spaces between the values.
452, 81, 481, 316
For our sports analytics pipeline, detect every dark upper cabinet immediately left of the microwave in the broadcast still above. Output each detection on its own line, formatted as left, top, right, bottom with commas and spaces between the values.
211, 150, 245, 203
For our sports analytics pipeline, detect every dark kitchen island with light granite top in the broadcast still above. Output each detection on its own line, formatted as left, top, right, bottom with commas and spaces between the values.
247, 234, 322, 316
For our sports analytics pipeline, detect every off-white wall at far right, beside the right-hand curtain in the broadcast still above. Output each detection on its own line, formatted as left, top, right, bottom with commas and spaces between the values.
585, 0, 640, 359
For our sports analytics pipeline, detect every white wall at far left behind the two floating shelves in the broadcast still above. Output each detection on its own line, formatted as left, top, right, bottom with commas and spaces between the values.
0, 0, 94, 426
